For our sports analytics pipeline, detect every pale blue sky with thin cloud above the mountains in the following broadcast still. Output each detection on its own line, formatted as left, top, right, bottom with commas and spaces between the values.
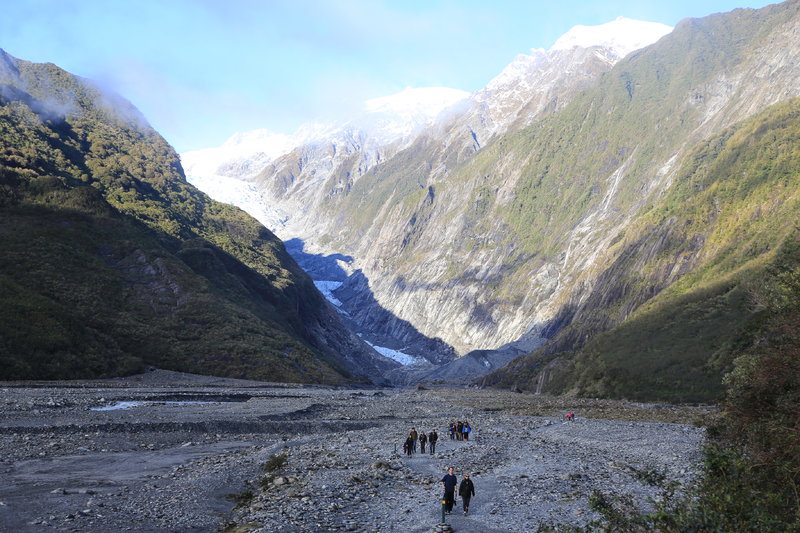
0, 0, 775, 152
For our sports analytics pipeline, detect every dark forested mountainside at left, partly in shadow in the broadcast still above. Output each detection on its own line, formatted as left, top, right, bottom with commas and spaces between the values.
0, 52, 394, 383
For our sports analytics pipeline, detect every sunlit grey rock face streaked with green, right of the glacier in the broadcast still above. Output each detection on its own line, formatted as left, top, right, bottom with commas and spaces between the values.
331, 2, 800, 353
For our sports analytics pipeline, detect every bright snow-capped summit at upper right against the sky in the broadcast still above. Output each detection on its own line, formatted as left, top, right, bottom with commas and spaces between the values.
550, 17, 672, 57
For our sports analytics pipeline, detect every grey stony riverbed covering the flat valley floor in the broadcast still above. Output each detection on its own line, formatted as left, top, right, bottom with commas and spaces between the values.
0, 371, 713, 533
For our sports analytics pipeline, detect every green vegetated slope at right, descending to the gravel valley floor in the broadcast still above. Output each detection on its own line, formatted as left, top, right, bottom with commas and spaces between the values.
485, 99, 800, 401
